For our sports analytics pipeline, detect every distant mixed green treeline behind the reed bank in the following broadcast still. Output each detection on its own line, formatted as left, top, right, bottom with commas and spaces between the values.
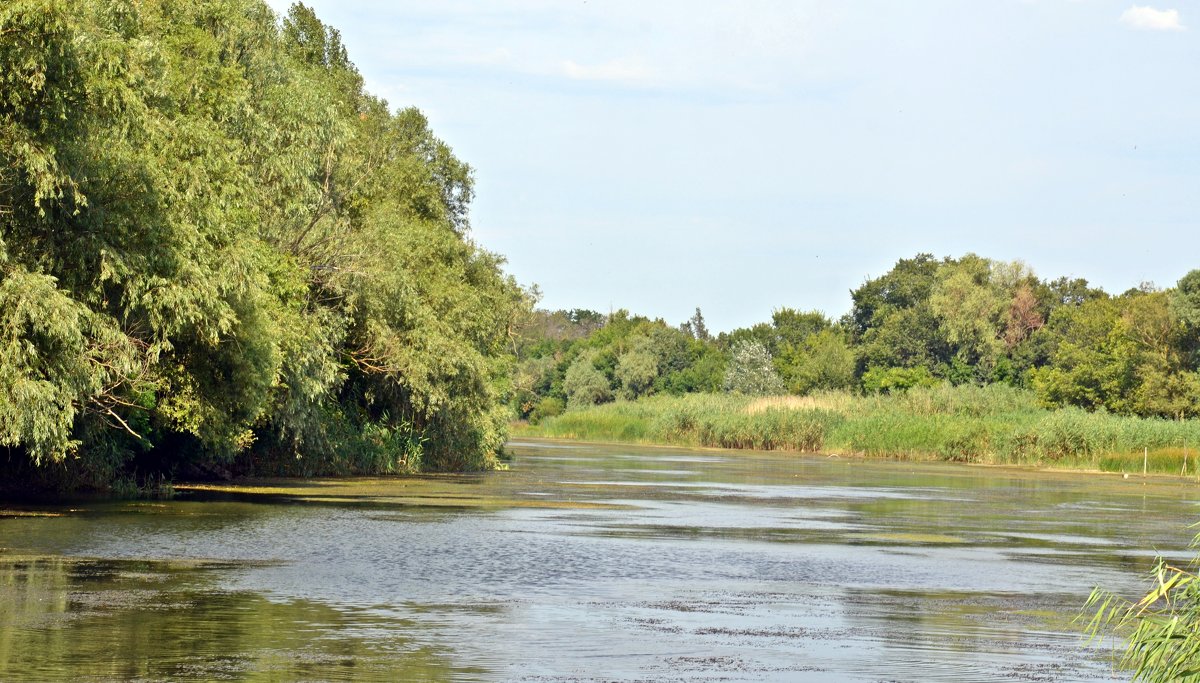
514, 254, 1200, 423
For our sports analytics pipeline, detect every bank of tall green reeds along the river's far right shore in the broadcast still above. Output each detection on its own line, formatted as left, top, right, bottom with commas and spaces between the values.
515, 385, 1200, 474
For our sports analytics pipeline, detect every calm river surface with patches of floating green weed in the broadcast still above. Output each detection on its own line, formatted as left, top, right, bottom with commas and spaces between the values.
0, 442, 1198, 681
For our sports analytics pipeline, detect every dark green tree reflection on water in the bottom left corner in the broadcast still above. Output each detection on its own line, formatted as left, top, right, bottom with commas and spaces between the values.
0, 557, 463, 681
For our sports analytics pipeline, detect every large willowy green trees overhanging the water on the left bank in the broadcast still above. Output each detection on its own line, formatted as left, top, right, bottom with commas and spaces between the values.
0, 0, 529, 485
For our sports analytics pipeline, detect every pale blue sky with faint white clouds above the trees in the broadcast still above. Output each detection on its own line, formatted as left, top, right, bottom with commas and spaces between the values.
262, 0, 1200, 331
